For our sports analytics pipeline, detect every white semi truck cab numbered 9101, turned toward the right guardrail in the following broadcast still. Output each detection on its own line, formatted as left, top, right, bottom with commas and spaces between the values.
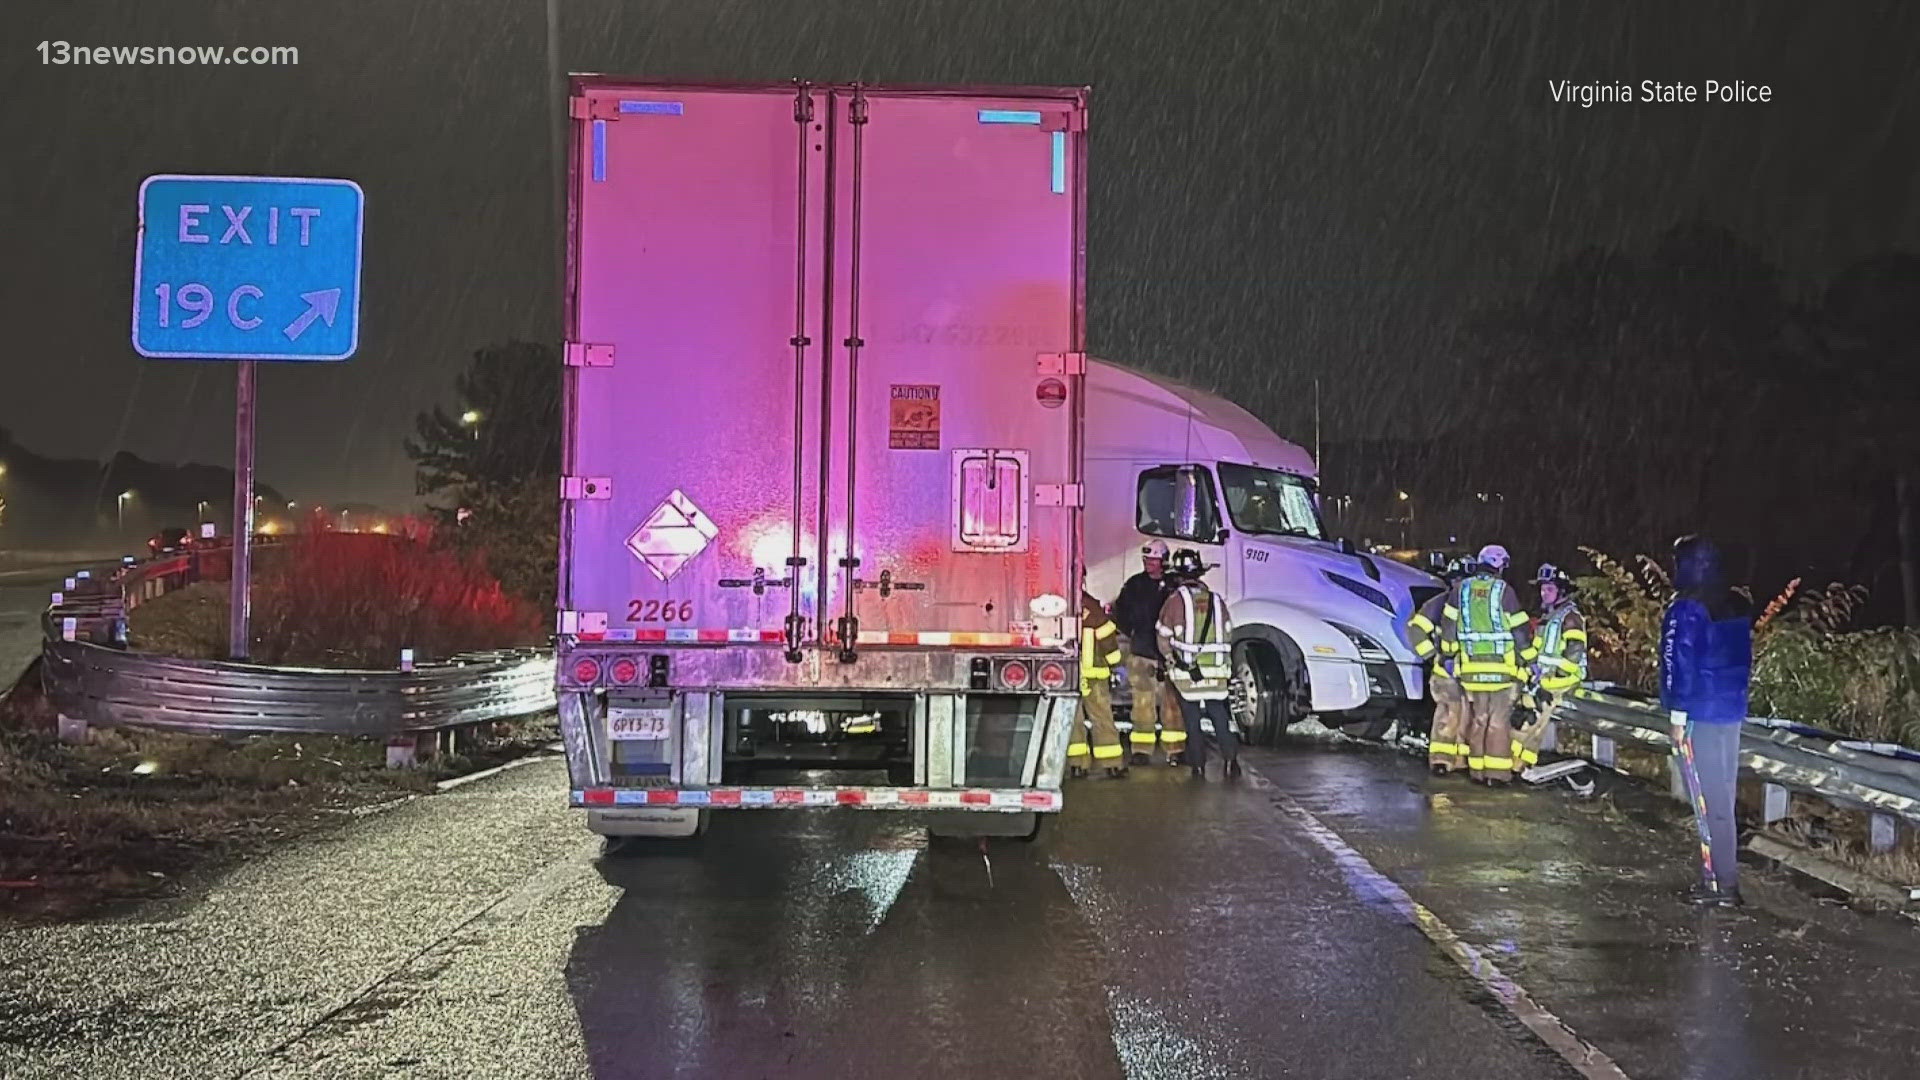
1085, 359, 1442, 744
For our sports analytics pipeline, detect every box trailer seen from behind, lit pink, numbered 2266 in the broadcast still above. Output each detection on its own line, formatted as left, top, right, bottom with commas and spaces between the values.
555, 77, 1087, 838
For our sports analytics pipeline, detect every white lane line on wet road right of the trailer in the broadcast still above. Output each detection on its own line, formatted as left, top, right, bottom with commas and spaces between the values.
1246, 769, 1630, 1080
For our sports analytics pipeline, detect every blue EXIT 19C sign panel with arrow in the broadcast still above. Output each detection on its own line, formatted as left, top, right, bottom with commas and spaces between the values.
132, 175, 367, 361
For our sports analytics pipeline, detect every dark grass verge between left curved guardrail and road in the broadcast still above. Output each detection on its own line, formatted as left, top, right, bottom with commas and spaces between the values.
0, 667, 555, 924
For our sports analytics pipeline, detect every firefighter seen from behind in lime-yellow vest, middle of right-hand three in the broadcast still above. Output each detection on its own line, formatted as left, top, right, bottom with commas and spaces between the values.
1440, 544, 1534, 786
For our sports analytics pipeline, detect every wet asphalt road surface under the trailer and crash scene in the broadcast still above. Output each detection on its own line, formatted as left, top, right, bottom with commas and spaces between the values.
0, 734, 1920, 1080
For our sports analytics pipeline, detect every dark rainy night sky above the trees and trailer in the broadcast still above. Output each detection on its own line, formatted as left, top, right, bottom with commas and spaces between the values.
0, 0, 1920, 503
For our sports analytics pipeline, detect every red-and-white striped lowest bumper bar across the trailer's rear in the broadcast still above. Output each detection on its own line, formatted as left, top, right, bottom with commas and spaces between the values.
570, 786, 1060, 813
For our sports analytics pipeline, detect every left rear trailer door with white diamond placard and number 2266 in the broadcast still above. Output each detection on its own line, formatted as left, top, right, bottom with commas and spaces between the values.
563, 85, 826, 646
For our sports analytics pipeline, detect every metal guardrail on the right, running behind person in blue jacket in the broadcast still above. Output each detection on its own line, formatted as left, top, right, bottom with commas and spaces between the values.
1553, 684, 1920, 824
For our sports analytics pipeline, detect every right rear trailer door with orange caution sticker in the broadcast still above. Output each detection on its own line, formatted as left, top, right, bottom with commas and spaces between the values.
818, 90, 1083, 646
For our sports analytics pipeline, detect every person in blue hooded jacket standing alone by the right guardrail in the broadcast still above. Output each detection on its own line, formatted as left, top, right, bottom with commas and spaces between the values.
1661, 536, 1753, 905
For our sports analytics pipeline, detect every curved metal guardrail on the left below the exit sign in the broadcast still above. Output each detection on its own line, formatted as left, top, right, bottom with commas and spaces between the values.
40, 555, 555, 736
